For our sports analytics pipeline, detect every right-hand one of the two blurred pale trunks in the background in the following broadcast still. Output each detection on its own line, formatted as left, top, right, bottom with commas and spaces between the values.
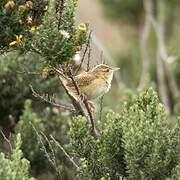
151, 0, 178, 114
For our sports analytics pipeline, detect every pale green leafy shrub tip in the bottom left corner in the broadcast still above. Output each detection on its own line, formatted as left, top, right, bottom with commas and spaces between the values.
0, 134, 35, 180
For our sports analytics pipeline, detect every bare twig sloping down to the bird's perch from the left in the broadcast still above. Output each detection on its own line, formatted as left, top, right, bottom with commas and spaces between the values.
30, 85, 76, 113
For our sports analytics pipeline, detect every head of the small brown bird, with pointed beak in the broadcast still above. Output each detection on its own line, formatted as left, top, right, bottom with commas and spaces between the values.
91, 64, 120, 78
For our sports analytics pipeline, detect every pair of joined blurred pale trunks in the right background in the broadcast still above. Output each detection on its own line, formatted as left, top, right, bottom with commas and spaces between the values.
139, 0, 178, 114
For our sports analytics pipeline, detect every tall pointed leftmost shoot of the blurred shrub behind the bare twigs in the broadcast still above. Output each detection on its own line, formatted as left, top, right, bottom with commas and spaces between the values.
15, 100, 46, 170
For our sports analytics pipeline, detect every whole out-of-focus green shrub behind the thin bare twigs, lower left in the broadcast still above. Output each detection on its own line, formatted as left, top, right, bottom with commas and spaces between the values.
15, 100, 73, 179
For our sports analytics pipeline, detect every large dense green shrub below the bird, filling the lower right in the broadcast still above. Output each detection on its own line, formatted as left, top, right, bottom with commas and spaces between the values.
70, 88, 180, 179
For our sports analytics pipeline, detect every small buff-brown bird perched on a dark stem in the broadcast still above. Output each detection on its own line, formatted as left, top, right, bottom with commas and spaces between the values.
54, 64, 120, 109
